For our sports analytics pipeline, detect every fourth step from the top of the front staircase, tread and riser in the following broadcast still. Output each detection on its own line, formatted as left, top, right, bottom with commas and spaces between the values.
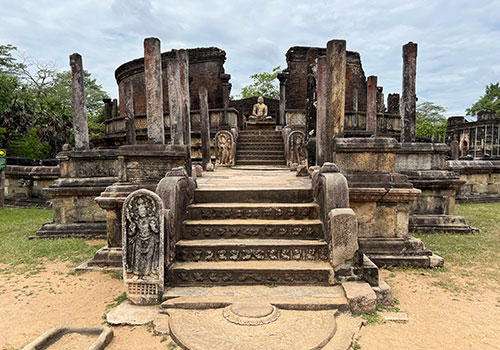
175, 239, 328, 261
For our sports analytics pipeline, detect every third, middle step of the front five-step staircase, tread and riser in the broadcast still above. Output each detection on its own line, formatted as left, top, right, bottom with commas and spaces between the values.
183, 219, 324, 239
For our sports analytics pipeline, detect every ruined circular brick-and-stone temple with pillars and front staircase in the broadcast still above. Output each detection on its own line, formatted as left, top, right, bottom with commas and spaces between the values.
18, 32, 500, 348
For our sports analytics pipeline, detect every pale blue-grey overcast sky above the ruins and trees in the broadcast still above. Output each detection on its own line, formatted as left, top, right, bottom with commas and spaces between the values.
0, 0, 500, 115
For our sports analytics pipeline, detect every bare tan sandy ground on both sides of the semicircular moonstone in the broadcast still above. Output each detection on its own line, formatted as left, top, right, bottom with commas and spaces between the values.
0, 263, 500, 350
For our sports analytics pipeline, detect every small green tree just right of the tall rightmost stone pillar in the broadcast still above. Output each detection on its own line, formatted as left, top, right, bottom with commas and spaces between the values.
415, 102, 447, 141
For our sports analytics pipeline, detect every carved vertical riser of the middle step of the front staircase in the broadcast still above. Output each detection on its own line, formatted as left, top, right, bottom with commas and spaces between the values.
182, 224, 324, 239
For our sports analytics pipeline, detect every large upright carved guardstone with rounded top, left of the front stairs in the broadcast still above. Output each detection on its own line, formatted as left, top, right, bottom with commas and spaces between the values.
122, 189, 165, 305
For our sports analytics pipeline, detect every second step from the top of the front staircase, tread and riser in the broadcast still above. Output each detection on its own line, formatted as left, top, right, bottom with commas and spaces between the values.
186, 203, 319, 220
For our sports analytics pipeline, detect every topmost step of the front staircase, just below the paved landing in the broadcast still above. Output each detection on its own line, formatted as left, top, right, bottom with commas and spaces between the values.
194, 188, 313, 203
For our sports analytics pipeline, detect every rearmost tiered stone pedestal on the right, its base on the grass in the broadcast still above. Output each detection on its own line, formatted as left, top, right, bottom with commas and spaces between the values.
396, 143, 478, 233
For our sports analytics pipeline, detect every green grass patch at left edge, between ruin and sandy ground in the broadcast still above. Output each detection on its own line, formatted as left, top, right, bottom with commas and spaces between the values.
0, 208, 103, 273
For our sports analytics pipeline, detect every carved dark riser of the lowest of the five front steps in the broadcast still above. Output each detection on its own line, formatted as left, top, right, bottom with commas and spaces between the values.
168, 268, 331, 286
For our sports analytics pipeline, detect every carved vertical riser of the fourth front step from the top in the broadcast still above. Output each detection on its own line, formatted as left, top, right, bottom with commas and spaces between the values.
176, 243, 328, 262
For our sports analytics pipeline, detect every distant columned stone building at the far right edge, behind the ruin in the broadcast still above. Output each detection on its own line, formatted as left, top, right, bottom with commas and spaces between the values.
446, 110, 500, 159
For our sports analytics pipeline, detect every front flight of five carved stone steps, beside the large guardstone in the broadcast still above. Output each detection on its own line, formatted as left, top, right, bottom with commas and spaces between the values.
168, 188, 334, 286
